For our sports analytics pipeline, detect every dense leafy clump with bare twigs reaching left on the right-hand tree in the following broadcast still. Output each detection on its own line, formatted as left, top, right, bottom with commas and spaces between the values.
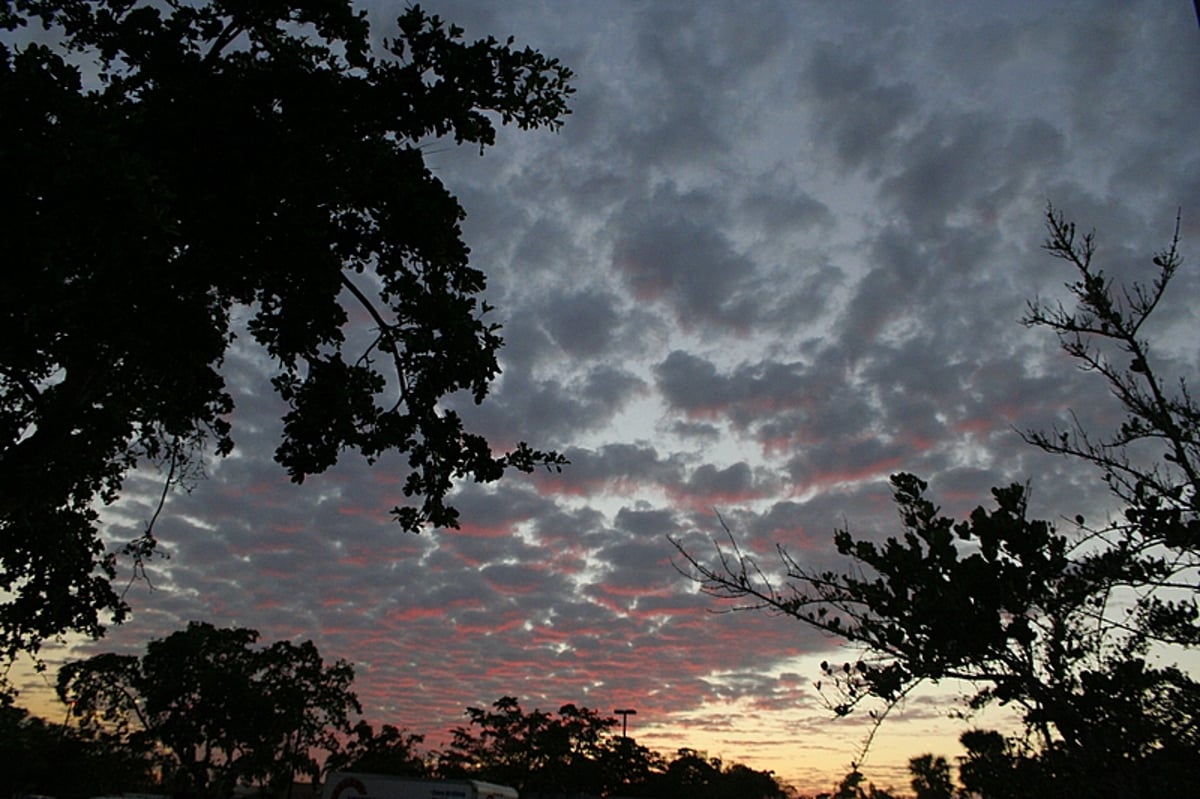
677, 474, 1088, 729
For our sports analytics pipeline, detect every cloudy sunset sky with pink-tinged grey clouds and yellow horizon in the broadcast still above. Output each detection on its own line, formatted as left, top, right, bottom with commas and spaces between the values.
11, 0, 1200, 789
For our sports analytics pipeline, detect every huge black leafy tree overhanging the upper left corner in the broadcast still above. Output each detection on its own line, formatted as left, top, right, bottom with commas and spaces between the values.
0, 0, 571, 656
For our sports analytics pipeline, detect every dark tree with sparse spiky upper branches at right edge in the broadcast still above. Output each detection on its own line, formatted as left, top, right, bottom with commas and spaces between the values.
677, 208, 1200, 797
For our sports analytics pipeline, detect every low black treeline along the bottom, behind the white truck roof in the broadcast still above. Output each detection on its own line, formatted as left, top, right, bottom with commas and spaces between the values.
7, 621, 787, 799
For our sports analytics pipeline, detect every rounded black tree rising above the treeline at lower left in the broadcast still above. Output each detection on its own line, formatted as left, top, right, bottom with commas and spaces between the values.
58, 621, 360, 797
